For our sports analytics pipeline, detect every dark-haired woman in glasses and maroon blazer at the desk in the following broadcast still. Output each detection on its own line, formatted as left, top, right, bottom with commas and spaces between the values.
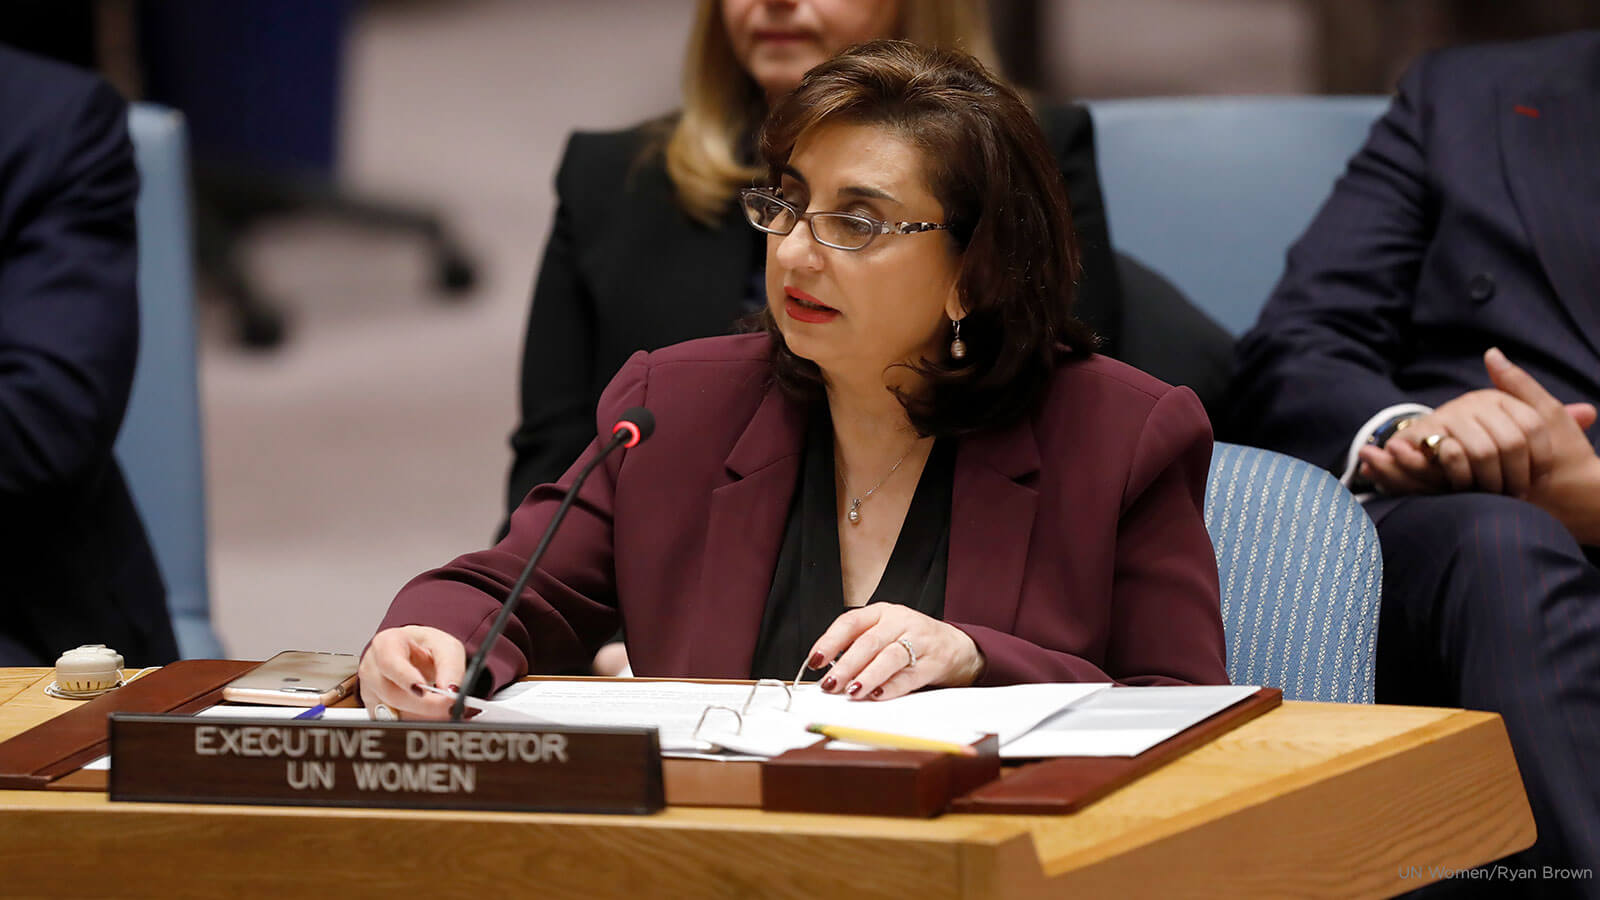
362, 42, 1227, 717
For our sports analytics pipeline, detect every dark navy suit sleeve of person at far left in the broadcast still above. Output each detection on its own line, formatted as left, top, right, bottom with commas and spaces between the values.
0, 78, 139, 504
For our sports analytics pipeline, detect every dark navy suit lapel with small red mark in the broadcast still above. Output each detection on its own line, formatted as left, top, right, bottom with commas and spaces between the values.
1496, 64, 1600, 354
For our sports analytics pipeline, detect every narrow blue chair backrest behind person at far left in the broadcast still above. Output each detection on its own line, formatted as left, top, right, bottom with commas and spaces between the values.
117, 104, 222, 657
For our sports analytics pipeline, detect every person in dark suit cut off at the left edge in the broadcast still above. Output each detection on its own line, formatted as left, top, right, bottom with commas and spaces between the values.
0, 46, 178, 666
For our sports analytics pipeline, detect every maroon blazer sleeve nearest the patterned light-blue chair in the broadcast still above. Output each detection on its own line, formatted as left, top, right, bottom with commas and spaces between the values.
952, 381, 1227, 685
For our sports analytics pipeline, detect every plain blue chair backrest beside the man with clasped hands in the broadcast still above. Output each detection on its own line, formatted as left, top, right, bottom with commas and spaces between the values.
1088, 96, 1389, 336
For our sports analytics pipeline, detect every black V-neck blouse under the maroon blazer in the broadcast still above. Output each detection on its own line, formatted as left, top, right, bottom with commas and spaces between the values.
750, 404, 955, 681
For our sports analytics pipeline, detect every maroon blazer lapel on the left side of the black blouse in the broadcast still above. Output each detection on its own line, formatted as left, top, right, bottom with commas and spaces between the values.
686, 377, 805, 677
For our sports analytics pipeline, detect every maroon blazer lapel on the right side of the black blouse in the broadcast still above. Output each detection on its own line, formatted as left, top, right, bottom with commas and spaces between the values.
944, 421, 1038, 631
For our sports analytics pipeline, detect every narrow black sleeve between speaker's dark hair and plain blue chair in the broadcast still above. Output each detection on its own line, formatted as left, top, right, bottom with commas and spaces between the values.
1040, 104, 1123, 359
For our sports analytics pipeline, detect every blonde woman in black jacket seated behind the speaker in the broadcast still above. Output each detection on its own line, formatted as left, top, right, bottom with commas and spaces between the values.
506, 0, 1122, 674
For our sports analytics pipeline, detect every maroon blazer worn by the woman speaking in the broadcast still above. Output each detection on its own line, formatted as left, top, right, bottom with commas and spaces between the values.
382, 335, 1227, 685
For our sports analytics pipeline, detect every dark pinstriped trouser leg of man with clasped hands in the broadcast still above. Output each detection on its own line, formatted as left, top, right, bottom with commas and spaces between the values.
1368, 493, 1600, 897
